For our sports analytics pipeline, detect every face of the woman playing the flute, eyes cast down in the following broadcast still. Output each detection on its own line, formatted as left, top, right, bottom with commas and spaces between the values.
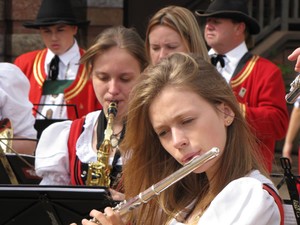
149, 87, 234, 176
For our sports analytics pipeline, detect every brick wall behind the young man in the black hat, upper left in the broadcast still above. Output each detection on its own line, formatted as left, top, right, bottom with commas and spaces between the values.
0, 0, 123, 62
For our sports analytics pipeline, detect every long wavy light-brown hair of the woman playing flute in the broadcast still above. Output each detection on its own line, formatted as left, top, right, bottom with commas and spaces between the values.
122, 53, 268, 225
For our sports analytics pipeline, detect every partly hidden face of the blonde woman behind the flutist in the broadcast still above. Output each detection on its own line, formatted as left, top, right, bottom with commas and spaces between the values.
149, 25, 189, 65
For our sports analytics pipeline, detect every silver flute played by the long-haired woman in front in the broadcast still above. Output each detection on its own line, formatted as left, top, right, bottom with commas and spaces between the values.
91, 147, 220, 224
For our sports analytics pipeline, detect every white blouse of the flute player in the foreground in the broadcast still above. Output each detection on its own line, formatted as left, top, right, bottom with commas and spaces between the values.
170, 170, 280, 225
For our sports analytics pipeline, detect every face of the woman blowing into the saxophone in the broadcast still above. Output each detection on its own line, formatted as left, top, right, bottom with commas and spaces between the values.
91, 47, 141, 122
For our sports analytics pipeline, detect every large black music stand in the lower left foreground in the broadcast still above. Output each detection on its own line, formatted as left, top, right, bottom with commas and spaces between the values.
0, 185, 115, 225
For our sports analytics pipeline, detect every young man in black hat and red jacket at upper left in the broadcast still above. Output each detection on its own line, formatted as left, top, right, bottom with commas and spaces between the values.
15, 0, 100, 120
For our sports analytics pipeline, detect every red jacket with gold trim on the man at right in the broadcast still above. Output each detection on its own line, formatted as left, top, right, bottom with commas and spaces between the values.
230, 55, 289, 172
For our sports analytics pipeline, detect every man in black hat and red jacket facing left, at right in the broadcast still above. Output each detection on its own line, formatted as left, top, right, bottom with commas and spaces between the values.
196, 0, 289, 172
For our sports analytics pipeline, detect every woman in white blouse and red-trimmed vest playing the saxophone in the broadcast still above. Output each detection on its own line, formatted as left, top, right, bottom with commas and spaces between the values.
35, 26, 147, 199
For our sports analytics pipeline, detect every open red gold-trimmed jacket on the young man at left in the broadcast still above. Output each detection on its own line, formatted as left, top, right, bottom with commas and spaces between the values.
15, 49, 101, 120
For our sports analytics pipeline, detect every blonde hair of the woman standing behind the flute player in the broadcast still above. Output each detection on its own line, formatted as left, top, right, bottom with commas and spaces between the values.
145, 6, 210, 62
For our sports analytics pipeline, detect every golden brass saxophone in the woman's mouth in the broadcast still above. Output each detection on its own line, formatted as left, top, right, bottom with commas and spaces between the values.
86, 102, 118, 187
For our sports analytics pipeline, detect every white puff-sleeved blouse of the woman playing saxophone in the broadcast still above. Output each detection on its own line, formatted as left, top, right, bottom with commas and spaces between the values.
35, 111, 122, 185
